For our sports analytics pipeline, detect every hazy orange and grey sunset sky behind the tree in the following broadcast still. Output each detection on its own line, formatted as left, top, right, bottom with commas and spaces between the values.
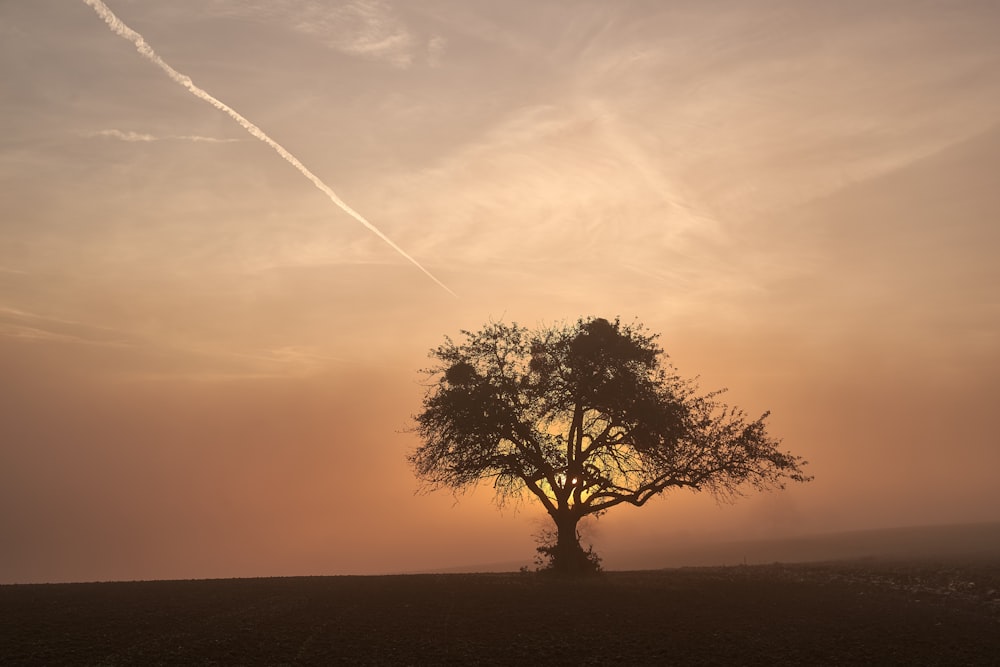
0, 0, 1000, 583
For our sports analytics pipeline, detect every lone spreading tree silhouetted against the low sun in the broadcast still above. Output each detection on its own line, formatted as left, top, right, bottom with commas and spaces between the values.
408, 318, 810, 573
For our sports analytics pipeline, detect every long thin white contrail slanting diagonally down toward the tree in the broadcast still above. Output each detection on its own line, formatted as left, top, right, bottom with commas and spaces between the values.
83, 0, 457, 296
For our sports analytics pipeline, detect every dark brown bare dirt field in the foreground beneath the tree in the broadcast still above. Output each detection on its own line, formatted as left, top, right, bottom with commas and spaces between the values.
0, 562, 1000, 665
